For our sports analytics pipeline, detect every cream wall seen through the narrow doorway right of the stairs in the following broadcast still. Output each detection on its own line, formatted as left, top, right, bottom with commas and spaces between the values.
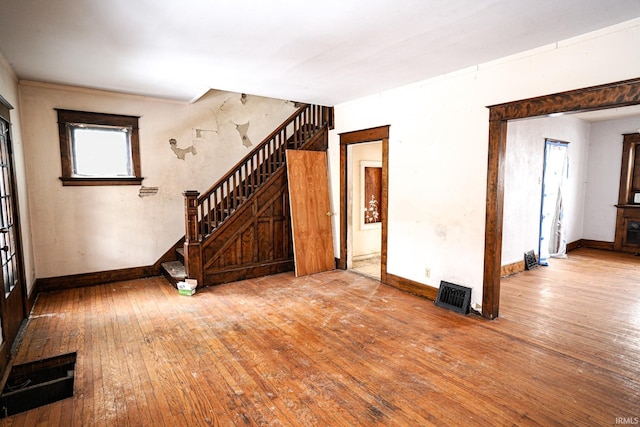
349, 142, 382, 259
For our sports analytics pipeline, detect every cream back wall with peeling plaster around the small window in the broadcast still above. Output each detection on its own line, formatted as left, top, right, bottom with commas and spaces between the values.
20, 82, 295, 278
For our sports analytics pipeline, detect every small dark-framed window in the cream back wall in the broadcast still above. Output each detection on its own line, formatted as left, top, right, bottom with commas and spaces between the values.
56, 109, 143, 185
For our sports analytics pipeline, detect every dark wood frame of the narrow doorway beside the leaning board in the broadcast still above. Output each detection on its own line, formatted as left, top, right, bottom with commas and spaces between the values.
338, 125, 389, 283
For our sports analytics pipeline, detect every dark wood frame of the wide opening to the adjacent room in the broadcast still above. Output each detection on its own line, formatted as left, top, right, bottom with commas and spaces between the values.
482, 78, 640, 319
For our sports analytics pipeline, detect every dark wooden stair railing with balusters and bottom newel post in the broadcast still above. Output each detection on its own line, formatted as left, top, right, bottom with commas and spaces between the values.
183, 104, 333, 284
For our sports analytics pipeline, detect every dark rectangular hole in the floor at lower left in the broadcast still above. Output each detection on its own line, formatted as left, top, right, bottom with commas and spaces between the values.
0, 353, 76, 418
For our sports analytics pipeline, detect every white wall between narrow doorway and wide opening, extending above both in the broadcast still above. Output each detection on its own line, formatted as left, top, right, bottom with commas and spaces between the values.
330, 19, 640, 307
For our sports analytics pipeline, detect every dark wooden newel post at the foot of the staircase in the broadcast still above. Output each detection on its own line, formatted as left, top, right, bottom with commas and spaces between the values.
182, 191, 203, 287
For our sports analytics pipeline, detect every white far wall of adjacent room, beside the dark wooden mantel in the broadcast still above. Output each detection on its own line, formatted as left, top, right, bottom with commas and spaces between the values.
583, 116, 640, 243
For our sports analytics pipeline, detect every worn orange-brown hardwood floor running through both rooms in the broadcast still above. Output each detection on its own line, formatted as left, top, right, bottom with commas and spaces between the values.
0, 250, 640, 426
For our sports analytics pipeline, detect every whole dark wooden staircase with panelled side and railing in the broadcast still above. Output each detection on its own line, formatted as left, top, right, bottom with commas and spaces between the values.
161, 104, 333, 288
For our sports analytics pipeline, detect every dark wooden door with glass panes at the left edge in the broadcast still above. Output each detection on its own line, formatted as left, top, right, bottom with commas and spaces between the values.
0, 106, 27, 364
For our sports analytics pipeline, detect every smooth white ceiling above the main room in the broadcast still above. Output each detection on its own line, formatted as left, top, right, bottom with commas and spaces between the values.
0, 0, 640, 105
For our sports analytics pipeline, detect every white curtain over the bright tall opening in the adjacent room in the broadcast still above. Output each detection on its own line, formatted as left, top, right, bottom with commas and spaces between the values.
538, 141, 569, 265
